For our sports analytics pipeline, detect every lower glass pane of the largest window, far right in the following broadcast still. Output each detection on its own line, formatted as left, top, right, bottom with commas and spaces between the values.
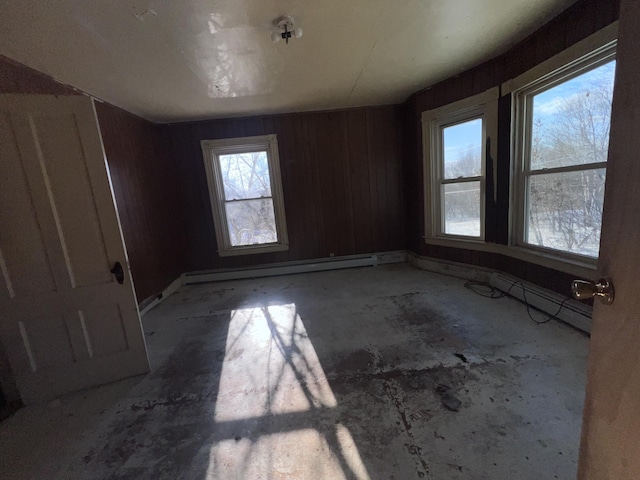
525, 168, 606, 257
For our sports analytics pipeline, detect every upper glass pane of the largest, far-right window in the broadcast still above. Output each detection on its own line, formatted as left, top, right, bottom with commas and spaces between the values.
531, 61, 616, 170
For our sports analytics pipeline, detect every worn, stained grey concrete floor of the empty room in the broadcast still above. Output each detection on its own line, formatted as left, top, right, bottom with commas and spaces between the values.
0, 264, 588, 480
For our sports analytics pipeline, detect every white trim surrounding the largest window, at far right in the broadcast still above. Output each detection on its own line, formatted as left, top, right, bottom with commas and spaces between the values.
505, 36, 617, 269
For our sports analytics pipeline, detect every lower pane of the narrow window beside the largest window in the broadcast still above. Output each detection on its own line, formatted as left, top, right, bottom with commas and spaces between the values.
442, 182, 480, 237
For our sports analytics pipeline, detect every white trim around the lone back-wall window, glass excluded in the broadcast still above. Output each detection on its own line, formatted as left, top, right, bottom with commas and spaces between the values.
200, 134, 289, 257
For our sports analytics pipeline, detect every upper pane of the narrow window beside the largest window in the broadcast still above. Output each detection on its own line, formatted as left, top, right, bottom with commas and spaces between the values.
442, 118, 482, 178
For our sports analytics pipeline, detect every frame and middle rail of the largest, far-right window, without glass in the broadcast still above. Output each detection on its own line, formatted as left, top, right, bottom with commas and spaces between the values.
511, 41, 617, 268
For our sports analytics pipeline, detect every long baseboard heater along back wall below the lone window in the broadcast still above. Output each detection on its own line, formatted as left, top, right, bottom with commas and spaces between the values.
182, 255, 378, 285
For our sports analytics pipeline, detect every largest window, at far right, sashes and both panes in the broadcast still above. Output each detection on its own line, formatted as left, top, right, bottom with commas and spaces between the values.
514, 45, 615, 262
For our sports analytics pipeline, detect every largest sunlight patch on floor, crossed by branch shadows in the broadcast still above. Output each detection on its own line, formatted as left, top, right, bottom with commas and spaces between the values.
214, 304, 336, 422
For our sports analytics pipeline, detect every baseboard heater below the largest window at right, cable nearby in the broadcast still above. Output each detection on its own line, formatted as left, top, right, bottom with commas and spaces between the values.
489, 273, 592, 333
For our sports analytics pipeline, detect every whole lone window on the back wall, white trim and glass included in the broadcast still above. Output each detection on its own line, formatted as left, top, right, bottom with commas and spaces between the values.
201, 135, 289, 256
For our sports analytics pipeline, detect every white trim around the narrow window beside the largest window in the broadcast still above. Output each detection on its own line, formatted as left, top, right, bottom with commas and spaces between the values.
422, 87, 499, 248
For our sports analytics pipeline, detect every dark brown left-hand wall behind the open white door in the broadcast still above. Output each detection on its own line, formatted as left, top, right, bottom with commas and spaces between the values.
0, 56, 183, 301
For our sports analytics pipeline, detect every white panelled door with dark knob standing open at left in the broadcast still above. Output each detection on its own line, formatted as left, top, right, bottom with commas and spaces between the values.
0, 95, 149, 404
